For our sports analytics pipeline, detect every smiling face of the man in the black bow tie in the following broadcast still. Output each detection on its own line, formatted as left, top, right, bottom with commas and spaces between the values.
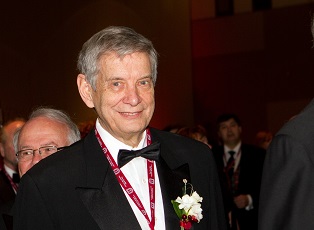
79, 52, 155, 145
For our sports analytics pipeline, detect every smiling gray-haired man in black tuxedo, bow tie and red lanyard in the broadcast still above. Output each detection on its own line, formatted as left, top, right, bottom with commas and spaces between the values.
14, 27, 226, 230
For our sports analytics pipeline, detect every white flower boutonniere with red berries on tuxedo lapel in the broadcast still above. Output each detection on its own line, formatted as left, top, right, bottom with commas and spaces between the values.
171, 179, 203, 230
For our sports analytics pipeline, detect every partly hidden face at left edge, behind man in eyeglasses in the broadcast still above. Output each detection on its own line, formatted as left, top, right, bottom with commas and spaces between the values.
0, 121, 24, 170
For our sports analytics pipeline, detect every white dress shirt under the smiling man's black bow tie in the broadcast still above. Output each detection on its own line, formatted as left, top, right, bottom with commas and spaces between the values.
96, 119, 166, 230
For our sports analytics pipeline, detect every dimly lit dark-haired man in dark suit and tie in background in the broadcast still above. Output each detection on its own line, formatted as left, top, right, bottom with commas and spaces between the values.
213, 114, 265, 230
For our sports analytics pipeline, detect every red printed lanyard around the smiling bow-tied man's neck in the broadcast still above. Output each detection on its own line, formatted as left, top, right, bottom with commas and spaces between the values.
95, 128, 155, 230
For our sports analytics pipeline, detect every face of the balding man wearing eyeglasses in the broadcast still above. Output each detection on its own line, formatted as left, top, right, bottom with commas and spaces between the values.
18, 117, 69, 176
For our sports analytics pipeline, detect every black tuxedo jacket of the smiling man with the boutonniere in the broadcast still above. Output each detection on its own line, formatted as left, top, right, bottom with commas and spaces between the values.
14, 129, 226, 230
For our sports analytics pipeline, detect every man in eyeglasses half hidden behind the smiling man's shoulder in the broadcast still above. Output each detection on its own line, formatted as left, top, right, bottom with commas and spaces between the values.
13, 108, 80, 177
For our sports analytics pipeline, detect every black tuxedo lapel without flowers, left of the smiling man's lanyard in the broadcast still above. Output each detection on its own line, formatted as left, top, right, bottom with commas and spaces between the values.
76, 133, 141, 230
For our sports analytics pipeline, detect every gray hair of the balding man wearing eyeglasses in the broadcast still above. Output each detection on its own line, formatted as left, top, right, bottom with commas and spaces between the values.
13, 107, 81, 152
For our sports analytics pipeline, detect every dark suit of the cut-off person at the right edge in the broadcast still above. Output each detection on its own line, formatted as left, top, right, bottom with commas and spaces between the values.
259, 100, 314, 230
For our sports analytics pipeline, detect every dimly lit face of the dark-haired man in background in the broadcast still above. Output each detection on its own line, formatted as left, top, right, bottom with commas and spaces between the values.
218, 118, 242, 146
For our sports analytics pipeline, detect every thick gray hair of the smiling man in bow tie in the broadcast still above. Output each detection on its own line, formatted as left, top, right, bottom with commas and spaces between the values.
77, 26, 158, 90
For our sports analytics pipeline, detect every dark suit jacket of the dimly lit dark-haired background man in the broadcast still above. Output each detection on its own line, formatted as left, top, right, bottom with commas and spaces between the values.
213, 144, 265, 230
